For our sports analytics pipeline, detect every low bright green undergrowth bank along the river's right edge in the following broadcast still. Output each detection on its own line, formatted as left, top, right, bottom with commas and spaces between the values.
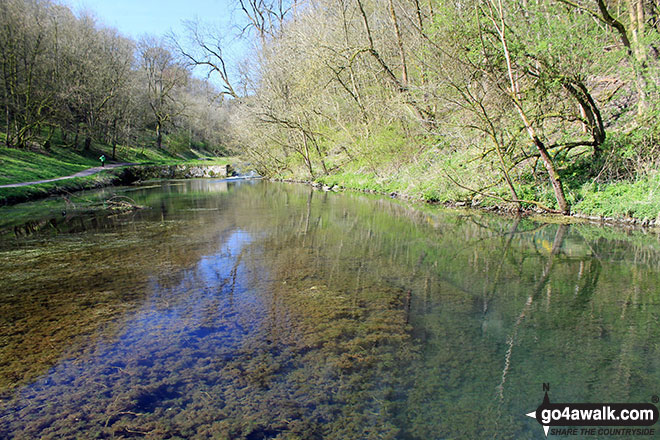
253, 113, 660, 230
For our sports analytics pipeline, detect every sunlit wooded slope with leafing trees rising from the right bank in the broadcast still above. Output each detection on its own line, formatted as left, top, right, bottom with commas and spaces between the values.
219, 0, 660, 220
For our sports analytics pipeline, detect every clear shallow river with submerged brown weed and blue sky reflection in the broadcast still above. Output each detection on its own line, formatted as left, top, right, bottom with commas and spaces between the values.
0, 180, 660, 440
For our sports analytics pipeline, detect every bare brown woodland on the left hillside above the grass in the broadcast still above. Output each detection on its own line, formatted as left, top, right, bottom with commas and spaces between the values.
0, 0, 232, 156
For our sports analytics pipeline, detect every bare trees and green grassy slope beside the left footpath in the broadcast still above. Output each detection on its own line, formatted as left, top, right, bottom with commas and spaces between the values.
0, 0, 236, 204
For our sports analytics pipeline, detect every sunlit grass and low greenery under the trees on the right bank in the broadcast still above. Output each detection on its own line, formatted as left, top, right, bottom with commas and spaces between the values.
272, 125, 660, 224
